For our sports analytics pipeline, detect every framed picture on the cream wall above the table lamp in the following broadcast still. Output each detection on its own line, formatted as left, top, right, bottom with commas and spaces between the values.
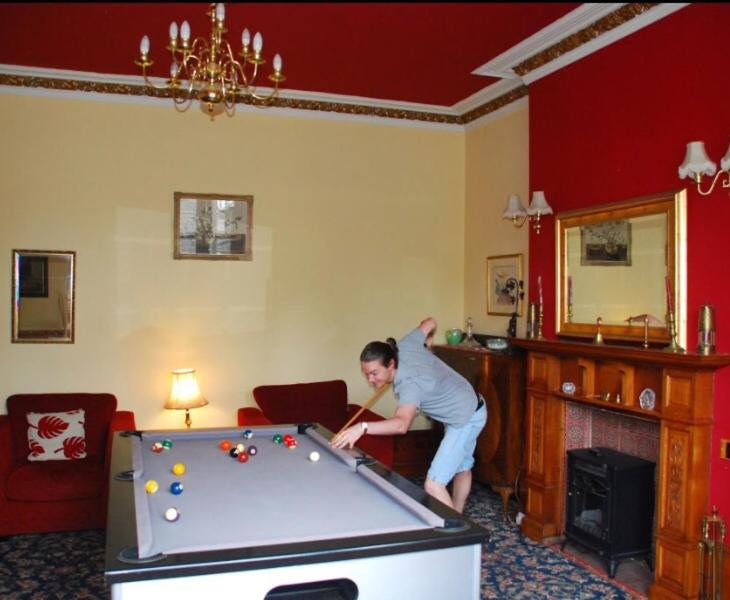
173, 192, 253, 260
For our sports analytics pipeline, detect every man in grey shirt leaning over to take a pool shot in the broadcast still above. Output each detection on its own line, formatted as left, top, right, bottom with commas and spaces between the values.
332, 317, 487, 512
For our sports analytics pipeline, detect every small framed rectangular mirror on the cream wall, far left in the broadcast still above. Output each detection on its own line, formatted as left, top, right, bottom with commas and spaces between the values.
11, 250, 76, 344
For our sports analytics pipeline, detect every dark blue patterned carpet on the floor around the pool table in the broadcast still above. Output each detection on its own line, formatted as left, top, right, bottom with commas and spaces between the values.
0, 483, 641, 600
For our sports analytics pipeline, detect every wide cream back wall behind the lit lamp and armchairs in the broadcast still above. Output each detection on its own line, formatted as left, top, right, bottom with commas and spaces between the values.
0, 95, 464, 428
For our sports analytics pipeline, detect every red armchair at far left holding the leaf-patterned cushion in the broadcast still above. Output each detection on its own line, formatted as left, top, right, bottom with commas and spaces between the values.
0, 394, 135, 536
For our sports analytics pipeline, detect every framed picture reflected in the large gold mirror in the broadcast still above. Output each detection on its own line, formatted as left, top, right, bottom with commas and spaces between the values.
580, 219, 631, 267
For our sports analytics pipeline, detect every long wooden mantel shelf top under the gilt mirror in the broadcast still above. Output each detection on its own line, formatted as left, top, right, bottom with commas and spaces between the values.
510, 338, 730, 370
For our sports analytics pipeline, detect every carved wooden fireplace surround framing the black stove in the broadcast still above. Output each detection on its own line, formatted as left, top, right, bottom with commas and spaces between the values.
512, 339, 730, 600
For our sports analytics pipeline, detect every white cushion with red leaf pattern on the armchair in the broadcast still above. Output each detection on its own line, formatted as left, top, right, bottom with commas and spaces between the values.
27, 408, 86, 461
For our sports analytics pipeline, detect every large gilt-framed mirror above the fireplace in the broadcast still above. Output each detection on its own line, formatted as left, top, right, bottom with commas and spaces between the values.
555, 190, 687, 348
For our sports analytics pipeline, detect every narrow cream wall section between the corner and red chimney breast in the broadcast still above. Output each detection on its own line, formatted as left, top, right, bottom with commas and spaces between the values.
464, 99, 528, 336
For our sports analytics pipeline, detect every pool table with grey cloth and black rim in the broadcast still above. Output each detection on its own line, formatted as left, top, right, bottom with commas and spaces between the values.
105, 424, 488, 600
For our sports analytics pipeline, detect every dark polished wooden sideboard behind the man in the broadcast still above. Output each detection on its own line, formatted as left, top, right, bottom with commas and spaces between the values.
433, 346, 525, 515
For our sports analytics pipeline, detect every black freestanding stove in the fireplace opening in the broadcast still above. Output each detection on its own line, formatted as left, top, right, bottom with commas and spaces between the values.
563, 448, 656, 578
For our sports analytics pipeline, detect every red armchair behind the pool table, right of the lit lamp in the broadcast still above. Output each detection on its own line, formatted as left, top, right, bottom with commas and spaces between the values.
238, 379, 395, 467
